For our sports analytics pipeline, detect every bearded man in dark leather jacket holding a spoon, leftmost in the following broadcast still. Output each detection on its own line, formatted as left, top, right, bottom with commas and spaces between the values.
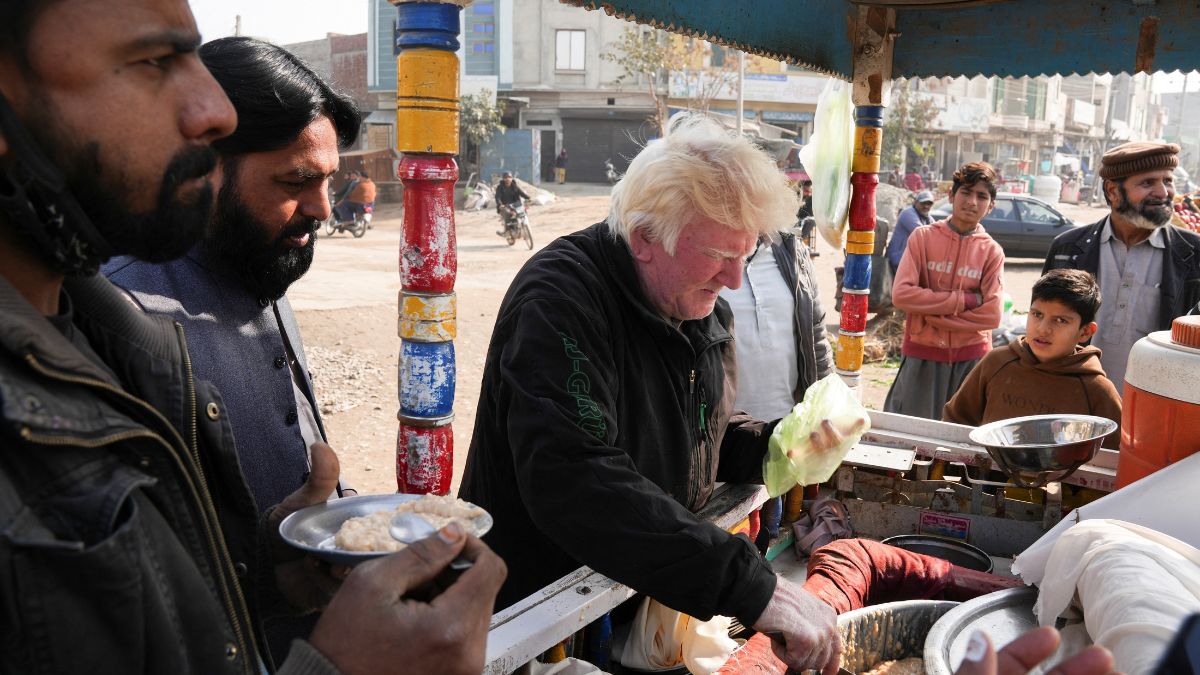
0, 0, 504, 675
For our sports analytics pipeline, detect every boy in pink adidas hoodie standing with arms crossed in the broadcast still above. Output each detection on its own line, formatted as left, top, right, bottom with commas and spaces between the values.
883, 162, 1004, 419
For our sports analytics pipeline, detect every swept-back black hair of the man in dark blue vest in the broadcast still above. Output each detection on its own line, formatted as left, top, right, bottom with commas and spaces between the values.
199, 37, 362, 155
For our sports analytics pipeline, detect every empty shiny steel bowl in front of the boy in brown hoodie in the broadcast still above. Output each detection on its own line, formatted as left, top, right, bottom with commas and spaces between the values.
970, 414, 1117, 488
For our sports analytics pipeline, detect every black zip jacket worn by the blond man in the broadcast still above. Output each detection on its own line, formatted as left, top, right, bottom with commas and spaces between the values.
460, 223, 775, 625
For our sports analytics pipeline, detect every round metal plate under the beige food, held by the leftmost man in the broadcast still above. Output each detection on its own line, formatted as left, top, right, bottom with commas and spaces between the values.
280, 495, 492, 566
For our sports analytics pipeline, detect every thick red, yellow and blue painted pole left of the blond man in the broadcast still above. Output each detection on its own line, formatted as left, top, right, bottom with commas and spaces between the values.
390, 0, 469, 495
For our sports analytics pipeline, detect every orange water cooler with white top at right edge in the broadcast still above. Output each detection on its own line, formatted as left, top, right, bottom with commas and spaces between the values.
1116, 316, 1200, 488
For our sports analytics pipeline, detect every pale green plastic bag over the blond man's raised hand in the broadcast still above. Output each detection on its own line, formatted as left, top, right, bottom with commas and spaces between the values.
762, 374, 871, 497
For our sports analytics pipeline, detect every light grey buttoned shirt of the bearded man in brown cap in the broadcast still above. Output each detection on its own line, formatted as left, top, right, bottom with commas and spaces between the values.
1092, 219, 1170, 393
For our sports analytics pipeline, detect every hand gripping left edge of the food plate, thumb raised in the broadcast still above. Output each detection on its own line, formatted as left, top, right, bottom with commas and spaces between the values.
266, 441, 349, 611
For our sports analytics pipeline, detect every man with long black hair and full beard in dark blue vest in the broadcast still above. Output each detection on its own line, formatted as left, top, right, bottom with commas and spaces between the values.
104, 37, 361, 657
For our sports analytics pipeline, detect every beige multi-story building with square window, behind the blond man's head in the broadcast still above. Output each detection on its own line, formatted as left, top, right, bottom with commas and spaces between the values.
367, 0, 824, 181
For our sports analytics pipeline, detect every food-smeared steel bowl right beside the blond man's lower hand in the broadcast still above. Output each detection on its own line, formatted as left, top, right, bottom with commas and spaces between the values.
838, 601, 959, 673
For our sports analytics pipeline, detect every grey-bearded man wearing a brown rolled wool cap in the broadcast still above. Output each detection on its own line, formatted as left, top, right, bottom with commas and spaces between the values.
1042, 142, 1200, 390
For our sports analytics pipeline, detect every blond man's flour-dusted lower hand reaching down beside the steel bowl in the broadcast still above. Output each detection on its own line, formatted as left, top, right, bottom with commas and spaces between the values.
754, 578, 841, 675
